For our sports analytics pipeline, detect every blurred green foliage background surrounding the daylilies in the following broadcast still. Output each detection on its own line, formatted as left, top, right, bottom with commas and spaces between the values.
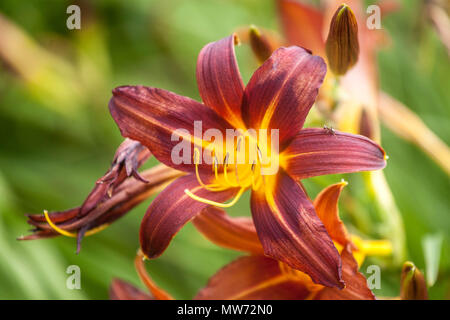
0, 0, 450, 299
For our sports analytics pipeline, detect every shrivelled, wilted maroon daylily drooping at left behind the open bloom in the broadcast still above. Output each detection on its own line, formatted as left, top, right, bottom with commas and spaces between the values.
18, 139, 183, 252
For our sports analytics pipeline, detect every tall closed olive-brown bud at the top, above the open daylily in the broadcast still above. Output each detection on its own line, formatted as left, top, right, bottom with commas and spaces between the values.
326, 4, 359, 75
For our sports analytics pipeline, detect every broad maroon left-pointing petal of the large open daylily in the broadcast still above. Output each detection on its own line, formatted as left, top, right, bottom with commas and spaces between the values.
109, 86, 233, 172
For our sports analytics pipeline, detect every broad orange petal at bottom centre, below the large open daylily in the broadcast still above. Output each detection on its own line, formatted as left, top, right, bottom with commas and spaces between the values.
195, 256, 310, 300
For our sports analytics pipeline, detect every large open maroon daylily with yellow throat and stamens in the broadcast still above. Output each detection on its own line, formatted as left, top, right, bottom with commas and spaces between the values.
109, 35, 386, 288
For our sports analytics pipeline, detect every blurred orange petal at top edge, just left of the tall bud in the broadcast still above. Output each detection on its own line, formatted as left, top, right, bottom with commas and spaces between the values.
277, 0, 325, 56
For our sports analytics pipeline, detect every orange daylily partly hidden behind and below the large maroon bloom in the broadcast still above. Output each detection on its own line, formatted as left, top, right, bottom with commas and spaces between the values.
110, 182, 391, 300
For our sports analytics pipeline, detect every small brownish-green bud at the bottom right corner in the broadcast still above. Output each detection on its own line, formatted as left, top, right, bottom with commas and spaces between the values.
400, 261, 428, 300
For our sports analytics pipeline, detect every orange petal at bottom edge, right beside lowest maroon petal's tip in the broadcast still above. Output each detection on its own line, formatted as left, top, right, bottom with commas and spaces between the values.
314, 245, 375, 300
